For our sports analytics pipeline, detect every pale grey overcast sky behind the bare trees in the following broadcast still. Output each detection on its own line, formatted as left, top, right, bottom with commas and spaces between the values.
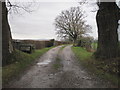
9, 2, 119, 39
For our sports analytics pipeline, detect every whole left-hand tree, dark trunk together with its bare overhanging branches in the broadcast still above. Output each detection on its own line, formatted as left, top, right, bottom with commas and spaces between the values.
0, 0, 38, 65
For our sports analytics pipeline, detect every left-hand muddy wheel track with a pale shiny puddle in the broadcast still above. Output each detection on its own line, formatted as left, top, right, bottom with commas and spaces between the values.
5, 46, 62, 88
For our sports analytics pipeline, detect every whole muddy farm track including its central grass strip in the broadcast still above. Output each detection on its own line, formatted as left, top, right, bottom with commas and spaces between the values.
6, 45, 111, 88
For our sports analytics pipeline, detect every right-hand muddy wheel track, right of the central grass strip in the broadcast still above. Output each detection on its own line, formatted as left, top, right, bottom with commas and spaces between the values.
52, 45, 112, 88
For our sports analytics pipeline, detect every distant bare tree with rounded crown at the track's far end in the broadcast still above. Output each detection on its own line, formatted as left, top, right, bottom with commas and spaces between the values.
55, 7, 90, 43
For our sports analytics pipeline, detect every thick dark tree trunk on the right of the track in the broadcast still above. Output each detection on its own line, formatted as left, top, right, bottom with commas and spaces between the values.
95, 2, 120, 58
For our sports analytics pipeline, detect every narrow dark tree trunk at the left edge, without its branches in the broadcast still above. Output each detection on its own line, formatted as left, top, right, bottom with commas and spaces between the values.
2, 2, 13, 65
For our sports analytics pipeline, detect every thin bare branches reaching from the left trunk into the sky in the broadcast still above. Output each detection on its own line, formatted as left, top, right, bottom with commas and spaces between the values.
6, 0, 39, 14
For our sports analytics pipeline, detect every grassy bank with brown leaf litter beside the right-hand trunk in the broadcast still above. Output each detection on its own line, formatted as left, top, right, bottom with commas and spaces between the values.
72, 47, 120, 86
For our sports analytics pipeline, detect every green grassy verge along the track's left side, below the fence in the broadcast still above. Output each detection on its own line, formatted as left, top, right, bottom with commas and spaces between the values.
2, 47, 53, 85
